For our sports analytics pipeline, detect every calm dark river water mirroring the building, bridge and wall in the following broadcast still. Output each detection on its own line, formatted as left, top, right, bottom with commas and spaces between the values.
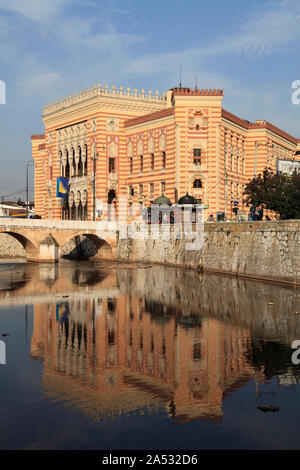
0, 261, 300, 450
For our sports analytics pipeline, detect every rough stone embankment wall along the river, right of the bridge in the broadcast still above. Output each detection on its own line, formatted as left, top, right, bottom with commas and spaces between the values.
117, 220, 300, 285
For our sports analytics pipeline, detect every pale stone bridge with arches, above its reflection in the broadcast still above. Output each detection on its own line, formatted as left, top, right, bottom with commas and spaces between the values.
0, 218, 116, 262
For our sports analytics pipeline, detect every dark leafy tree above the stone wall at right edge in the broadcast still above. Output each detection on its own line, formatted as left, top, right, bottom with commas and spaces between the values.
243, 168, 300, 219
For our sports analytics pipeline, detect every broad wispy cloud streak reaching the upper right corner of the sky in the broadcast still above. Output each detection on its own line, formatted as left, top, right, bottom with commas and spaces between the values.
126, 0, 300, 75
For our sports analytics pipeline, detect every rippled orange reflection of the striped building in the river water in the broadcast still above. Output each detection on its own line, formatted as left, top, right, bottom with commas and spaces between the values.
31, 296, 252, 422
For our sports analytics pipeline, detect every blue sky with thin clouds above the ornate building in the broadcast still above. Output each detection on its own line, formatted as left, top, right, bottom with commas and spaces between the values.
0, 0, 300, 200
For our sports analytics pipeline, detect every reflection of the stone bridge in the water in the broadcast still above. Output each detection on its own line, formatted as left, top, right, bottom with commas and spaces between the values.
0, 262, 119, 308
